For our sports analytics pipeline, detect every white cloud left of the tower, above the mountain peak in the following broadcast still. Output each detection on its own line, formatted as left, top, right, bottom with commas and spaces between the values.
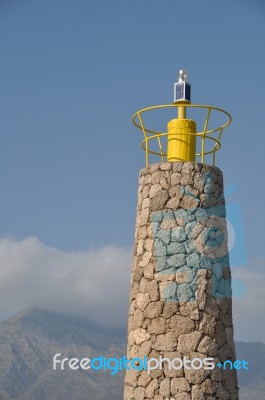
0, 237, 132, 326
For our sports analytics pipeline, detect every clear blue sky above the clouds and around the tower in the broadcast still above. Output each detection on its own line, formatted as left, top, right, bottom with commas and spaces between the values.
0, 0, 265, 340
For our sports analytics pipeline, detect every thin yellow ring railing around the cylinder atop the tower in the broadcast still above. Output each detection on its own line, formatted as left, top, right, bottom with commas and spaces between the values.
132, 103, 232, 165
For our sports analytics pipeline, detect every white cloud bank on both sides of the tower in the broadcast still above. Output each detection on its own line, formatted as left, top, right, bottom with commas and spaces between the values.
0, 237, 265, 342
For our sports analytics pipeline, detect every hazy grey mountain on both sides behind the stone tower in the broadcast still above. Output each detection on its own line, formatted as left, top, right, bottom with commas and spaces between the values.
0, 309, 265, 400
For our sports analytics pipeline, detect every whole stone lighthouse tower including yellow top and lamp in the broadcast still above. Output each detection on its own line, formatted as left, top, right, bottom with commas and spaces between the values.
124, 70, 239, 400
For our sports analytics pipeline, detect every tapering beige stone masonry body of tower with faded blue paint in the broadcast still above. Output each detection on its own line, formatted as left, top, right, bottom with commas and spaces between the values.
124, 162, 238, 400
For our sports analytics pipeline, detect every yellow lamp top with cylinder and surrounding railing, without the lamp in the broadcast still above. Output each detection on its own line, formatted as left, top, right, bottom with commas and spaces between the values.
133, 102, 232, 165
